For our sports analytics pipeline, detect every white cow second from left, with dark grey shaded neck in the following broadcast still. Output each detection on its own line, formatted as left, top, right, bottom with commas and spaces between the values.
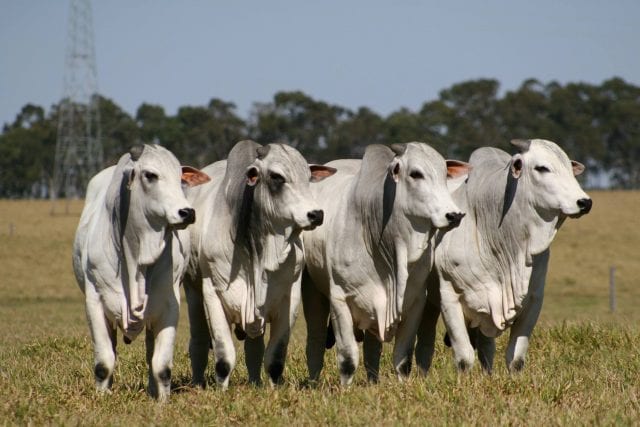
185, 141, 335, 388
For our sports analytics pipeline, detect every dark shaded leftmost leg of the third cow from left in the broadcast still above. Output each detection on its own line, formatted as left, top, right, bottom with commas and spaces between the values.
302, 270, 329, 381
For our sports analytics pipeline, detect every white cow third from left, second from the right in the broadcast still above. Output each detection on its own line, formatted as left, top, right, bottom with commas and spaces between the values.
302, 142, 468, 385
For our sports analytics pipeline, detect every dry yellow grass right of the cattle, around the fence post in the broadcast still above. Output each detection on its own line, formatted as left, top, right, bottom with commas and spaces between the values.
542, 191, 640, 323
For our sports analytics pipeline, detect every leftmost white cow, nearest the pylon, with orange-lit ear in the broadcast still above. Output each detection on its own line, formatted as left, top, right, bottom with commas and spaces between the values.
73, 145, 209, 400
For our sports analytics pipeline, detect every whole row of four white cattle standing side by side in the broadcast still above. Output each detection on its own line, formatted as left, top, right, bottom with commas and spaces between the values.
73, 139, 592, 400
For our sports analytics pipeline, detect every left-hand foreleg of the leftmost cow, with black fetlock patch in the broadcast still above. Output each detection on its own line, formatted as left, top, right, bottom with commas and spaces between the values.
85, 280, 116, 392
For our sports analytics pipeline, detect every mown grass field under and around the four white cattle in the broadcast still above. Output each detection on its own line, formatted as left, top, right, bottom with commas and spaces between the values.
0, 192, 640, 425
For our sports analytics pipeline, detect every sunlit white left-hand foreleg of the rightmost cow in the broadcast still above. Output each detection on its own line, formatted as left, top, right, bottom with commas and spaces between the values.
440, 278, 475, 371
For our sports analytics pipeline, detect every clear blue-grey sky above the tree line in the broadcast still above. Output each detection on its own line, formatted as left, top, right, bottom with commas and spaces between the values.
0, 0, 640, 124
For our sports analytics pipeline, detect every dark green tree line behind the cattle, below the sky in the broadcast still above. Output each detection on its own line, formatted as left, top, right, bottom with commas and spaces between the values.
0, 78, 640, 198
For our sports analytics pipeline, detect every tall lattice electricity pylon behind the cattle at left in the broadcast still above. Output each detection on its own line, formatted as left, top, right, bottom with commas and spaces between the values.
50, 0, 103, 213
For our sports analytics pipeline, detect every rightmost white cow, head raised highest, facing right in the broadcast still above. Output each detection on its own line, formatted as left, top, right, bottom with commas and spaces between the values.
416, 139, 592, 372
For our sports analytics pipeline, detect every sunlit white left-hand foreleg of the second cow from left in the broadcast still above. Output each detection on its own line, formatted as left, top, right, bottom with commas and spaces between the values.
202, 278, 236, 390
